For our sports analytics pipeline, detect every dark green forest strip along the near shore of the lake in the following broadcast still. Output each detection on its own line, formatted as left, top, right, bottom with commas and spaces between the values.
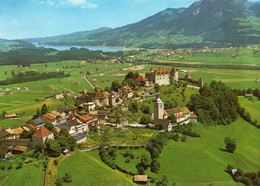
0, 47, 124, 67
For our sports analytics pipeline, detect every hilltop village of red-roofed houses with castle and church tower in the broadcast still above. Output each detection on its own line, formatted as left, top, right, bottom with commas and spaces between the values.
0, 66, 200, 158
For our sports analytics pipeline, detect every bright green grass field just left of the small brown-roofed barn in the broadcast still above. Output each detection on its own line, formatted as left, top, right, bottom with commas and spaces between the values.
57, 151, 134, 186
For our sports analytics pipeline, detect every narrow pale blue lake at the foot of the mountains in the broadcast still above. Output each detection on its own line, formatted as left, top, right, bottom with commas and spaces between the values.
33, 43, 132, 52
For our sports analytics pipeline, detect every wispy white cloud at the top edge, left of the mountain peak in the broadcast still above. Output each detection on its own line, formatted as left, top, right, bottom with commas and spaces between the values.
40, 0, 98, 8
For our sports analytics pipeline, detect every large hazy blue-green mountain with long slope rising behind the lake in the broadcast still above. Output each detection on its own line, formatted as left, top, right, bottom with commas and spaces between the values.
29, 0, 260, 48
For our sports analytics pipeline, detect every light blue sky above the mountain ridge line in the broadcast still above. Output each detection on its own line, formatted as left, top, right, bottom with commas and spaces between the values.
0, 0, 259, 39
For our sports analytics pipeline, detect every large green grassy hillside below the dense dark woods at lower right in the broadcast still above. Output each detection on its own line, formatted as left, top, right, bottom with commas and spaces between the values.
159, 119, 260, 185
